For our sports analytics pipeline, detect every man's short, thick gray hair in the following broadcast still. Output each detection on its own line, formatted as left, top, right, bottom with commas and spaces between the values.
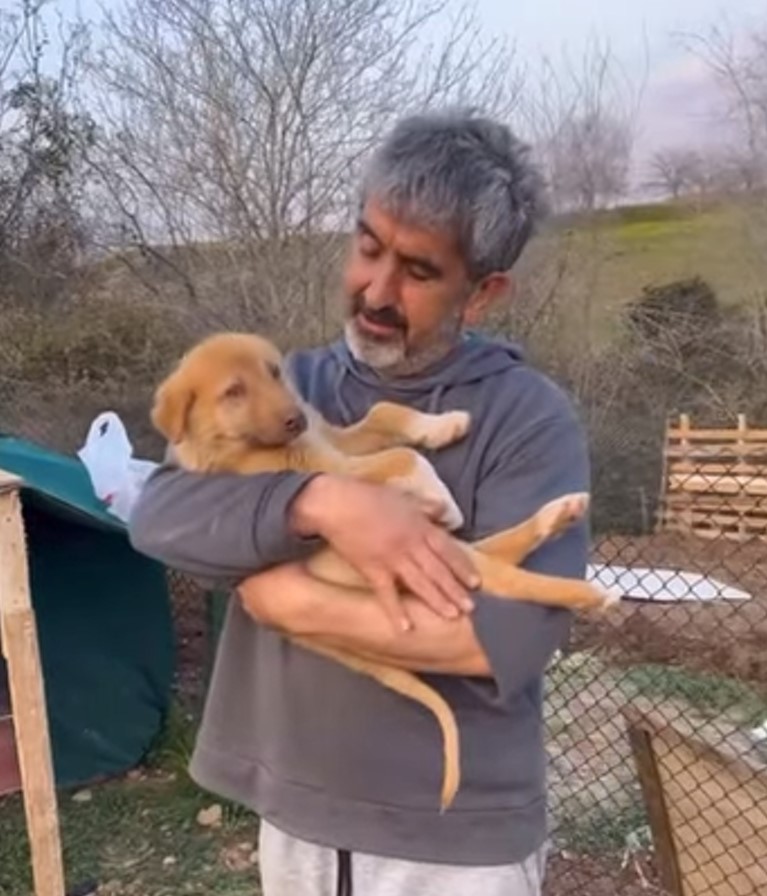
360, 110, 546, 280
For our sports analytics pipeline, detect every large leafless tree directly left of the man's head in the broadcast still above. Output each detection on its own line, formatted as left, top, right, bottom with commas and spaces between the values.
78, 0, 516, 339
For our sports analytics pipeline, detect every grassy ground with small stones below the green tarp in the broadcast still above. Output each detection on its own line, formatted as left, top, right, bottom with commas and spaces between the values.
0, 713, 259, 896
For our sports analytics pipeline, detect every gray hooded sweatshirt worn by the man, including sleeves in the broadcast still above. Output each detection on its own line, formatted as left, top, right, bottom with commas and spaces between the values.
130, 335, 590, 865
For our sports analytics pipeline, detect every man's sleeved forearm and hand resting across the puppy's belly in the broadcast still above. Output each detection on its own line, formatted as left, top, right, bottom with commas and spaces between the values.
129, 464, 475, 629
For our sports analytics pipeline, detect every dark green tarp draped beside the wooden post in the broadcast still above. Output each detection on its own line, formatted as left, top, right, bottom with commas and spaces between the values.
0, 436, 174, 787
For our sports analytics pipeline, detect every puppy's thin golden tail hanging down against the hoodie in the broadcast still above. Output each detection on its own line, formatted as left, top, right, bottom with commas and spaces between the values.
294, 638, 461, 812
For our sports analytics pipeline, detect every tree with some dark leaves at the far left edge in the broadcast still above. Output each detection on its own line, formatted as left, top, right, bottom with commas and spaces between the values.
0, 0, 93, 304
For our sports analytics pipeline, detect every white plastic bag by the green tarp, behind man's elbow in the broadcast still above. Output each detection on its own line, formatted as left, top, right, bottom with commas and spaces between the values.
77, 411, 157, 522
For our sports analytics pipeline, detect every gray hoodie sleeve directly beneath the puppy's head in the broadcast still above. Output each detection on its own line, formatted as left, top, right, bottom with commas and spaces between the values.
128, 462, 320, 586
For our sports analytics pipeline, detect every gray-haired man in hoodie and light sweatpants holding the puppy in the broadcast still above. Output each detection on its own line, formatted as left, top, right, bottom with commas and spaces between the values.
131, 113, 589, 896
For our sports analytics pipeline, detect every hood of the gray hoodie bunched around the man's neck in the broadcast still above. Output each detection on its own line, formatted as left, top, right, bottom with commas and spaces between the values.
330, 332, 524, 413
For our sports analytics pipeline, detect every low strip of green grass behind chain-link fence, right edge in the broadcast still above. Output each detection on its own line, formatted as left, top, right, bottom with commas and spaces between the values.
619, 663, 767, 727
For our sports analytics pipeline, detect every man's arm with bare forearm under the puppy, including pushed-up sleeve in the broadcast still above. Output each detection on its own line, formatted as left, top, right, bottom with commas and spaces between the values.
240, 400, 589, 701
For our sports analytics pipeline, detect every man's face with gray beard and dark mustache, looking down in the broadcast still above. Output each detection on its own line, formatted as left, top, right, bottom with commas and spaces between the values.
343, 201, 505, 375
